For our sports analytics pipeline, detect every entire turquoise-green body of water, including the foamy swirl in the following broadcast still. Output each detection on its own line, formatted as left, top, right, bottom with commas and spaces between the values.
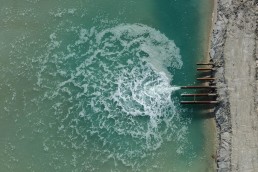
0, 0, 214, 172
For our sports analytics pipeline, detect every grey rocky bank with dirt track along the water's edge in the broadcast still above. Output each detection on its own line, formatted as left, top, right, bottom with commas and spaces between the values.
209, 0, 258, 172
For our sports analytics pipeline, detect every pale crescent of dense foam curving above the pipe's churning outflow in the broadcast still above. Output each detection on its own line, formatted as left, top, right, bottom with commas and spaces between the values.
96, 24, 182, 77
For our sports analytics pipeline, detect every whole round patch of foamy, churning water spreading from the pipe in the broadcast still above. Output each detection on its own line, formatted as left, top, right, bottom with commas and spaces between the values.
34, 24, 187, 168
